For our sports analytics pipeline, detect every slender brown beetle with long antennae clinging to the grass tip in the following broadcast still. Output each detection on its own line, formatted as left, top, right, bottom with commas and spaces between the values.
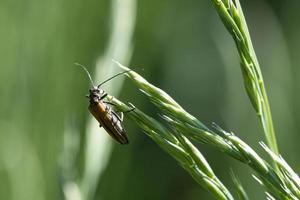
75, 63, 134, 144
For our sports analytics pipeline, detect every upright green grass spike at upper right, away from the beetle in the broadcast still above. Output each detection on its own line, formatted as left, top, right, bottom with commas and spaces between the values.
212, 0, 278, 156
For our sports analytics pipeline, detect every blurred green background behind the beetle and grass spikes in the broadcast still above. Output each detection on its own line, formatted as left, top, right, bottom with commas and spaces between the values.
0, 0, 300, 200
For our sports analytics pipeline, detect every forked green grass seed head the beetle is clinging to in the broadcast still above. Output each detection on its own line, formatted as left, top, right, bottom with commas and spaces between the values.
109, 60, 300, 199
